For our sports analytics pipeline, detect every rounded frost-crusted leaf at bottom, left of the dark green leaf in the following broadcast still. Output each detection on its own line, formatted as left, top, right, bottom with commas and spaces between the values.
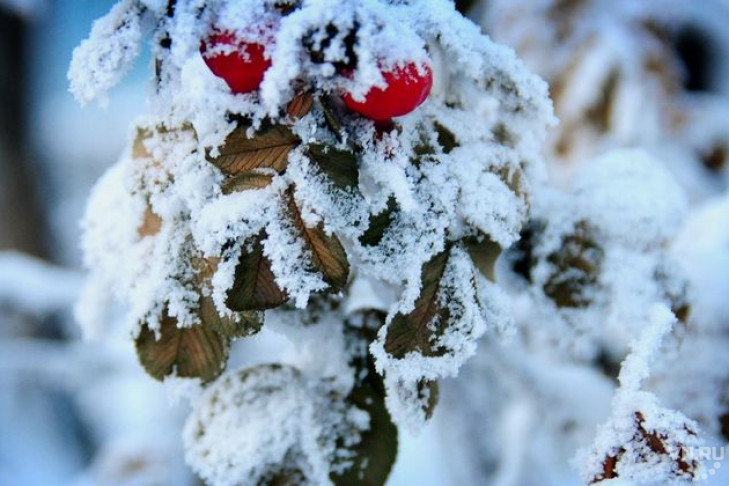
185, 364, 310, 486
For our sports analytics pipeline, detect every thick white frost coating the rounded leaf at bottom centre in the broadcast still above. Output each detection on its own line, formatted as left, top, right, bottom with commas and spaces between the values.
184, 366, 356, 486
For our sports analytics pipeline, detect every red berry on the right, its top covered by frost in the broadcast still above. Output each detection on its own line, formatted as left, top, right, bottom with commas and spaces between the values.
343, 62, 433, 121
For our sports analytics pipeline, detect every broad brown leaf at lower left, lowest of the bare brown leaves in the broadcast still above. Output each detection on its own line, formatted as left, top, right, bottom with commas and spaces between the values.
135, 315, 230, 382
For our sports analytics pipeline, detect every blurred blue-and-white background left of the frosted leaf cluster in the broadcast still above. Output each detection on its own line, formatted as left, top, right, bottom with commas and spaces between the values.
0, 0, 192, 486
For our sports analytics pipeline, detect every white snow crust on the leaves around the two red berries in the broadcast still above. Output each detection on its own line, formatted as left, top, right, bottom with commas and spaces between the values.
75, 0, 553, 402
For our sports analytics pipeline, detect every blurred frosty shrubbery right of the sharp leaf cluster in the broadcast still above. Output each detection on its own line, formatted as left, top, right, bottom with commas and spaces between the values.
426, 0, 728, 485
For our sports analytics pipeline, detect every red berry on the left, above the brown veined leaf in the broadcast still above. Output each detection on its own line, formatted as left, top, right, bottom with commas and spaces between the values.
200, 32, 271, 94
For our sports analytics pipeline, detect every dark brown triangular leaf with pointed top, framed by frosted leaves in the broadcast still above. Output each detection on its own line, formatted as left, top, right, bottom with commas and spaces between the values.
226, 233, 288, 311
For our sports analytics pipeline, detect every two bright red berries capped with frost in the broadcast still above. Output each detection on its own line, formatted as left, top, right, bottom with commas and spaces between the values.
200, 32, 433, 121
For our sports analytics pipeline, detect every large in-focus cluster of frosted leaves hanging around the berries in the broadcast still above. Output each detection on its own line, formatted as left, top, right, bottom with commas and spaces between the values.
69, 0, 554, 485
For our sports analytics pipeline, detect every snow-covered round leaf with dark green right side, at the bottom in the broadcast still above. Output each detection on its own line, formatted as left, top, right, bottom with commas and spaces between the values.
184, 365, 397, 485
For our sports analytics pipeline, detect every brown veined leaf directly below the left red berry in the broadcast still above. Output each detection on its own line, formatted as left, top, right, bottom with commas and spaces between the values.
208, 125, 299, 175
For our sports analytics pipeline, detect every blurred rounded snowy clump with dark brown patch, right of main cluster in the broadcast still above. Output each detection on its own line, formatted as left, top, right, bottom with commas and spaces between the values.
510, 150, 687, 358
